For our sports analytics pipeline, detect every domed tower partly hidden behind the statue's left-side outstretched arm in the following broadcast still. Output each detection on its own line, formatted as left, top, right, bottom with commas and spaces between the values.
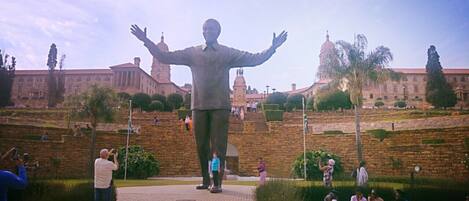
151, 33, 171, 83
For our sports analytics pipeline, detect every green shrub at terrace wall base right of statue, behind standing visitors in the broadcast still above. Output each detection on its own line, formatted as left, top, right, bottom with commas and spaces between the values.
292, 150, 343, 180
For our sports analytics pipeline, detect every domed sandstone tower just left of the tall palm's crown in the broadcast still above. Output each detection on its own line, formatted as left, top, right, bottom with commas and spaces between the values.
316, 32, 335, 80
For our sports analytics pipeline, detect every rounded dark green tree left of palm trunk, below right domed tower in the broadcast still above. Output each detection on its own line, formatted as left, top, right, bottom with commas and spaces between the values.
316, 90, 352, 110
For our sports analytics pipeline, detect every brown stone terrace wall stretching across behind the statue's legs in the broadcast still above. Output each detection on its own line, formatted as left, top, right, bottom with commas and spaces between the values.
0, 122, 469, 181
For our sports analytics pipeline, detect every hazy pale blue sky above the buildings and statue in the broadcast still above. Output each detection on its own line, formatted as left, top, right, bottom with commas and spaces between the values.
0, 0, 469, 92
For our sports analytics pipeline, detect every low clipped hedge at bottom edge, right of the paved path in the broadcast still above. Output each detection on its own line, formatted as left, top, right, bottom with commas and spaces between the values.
254, 180, 302, 201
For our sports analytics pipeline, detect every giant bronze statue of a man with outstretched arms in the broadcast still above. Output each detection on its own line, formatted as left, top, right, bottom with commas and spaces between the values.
130, 19, 287, 192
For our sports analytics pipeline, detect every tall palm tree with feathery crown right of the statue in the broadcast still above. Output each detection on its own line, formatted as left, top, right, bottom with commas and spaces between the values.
327, 34, 400, 161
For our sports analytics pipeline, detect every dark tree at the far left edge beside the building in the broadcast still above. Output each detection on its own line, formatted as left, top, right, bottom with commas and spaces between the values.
0, 50, 16, 107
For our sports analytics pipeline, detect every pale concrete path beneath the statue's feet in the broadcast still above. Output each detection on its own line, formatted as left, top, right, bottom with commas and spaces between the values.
117, 185, 255, 201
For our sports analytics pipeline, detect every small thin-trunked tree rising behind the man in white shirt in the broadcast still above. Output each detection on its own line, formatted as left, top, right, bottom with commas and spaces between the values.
66, 85, 117, 178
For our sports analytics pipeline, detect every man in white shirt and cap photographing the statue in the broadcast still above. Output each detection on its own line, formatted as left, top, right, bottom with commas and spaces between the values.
94, 149, 119, 201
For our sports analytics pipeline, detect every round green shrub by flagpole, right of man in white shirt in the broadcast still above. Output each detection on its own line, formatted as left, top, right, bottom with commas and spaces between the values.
114, 146, 160, 179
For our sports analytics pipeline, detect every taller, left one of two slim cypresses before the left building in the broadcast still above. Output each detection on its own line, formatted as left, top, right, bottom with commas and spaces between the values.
47, 43, 57, 107
